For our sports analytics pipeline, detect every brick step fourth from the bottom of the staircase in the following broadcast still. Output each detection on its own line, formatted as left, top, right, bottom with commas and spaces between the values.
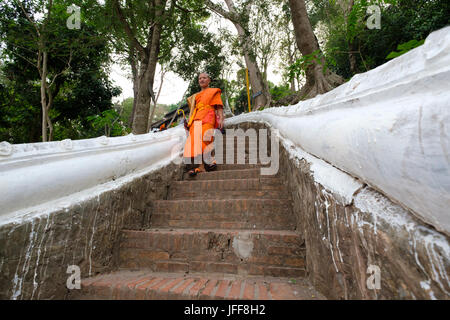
168, 178, 289, 200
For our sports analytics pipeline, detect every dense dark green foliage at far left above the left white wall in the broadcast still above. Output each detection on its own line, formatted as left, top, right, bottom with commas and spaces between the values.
0, 0, 120, 143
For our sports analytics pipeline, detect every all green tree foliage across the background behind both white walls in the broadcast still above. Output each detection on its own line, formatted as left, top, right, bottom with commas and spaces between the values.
0, 0, 450, 143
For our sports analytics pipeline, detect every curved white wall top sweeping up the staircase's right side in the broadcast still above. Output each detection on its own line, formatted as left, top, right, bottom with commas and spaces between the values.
226, 27, 450, 234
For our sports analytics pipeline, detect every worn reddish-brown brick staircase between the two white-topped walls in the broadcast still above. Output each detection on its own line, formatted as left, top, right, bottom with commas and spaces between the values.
75, 138, 323, 300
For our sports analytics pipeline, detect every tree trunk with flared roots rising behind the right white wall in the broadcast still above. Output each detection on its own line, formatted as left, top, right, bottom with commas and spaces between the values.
289, 0, 343, 99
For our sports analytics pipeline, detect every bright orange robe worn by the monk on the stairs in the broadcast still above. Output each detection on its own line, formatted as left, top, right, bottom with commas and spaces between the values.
183, 88, 223, 158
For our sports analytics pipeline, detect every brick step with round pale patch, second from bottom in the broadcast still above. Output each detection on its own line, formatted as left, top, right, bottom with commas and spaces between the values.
119, 229, 305, 277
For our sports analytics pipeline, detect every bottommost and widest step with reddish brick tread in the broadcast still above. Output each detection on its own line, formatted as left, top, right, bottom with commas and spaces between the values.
69, 271, 325, 300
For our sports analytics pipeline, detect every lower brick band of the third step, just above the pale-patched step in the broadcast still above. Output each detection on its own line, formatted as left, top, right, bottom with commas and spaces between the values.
151, 211, 296, 230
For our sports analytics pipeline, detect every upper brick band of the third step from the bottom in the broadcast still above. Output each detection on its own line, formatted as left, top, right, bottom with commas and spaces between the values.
152, 199, 292, 215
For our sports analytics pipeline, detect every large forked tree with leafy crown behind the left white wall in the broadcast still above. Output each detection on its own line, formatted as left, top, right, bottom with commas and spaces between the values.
101, 0, 220, 134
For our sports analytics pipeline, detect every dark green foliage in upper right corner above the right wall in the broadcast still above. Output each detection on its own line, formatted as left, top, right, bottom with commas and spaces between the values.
309, 0, 450, 79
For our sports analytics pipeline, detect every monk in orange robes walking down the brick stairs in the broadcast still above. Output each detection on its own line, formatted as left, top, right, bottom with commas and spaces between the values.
183, 72, 224, 176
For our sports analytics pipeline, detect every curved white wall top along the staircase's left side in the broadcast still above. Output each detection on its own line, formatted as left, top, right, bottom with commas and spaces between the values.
0, 127, 186, 221
